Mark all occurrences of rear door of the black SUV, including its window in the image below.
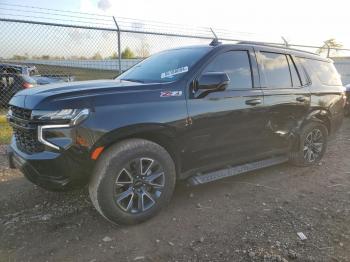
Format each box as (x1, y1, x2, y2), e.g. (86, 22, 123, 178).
(257, 49, 311, 153)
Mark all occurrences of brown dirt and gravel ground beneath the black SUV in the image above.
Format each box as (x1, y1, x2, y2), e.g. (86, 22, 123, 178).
(0, 120, 350, 262)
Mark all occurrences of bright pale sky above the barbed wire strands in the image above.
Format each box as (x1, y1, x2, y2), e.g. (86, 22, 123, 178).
(0, 0, 350, 50)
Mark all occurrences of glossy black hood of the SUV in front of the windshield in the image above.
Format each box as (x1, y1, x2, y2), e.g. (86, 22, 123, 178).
(9, 80, 162, 110)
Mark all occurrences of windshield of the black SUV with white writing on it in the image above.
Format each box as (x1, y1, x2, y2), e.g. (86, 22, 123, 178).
(116, 47, 209, 83)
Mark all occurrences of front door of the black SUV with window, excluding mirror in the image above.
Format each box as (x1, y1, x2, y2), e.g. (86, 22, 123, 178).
(183, 47, 264, 172)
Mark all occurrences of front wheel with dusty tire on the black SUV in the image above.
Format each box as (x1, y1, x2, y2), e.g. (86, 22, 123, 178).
(89, 139, 176, 224)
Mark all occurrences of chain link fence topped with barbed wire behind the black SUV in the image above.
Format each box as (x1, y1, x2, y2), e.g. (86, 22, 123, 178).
(0, 5, 350, 108)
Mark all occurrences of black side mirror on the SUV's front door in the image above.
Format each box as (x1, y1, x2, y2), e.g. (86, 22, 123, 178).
(196, 72, 230, 91)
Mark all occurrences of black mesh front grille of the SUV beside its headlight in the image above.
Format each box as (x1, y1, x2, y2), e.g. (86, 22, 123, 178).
(9, 106, 44, 154)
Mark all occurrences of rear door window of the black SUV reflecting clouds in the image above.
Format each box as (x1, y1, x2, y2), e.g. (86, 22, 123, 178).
(260, 52, 292, 88)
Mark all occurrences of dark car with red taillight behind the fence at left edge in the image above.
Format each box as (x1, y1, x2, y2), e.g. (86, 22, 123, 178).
(0, 73, 37, 108)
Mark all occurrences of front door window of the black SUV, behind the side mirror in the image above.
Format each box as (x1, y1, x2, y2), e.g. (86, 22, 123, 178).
(203, 51, 253, 90)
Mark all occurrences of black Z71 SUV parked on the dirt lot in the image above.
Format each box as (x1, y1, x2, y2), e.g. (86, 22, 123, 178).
(8, 42, 345, 224)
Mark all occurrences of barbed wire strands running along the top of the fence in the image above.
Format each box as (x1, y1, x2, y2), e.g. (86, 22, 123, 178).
(0, 3, 350, 51)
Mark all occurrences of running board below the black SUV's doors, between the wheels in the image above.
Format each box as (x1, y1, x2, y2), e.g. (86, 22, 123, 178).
(188, 156, 288, 186)
